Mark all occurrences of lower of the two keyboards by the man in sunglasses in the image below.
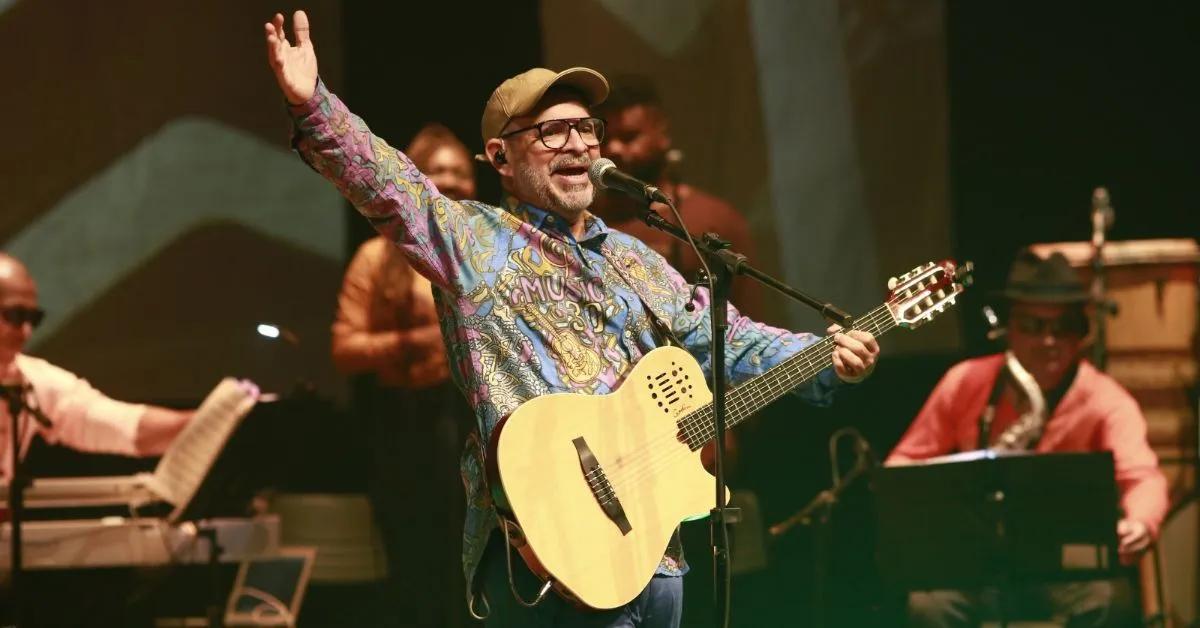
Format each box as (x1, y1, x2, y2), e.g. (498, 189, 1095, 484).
(0, 515, 280, 570)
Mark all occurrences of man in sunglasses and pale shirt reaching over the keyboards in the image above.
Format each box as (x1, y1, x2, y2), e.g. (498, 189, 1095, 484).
(0, 253, 193, 478)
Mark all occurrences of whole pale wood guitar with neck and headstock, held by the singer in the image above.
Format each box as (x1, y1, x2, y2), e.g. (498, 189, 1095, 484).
(487, 261, 971, 609)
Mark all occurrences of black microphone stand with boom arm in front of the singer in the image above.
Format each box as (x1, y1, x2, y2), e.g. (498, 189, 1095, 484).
(642, 207, 853, 627)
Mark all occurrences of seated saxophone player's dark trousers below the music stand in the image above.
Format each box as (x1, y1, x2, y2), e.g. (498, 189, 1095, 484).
(908, 580, 1138, 628)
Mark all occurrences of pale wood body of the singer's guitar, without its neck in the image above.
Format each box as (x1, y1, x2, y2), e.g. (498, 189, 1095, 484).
(492, 347, 728, 609)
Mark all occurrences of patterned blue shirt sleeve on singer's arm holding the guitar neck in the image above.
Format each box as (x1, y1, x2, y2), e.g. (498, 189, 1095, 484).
(662, 241, 852, 406)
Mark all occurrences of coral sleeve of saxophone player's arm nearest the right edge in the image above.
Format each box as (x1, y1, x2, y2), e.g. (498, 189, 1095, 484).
(1100, 396, 1169, 537)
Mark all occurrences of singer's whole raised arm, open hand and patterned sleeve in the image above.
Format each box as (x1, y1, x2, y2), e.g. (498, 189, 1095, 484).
(265, 11, 482, 292)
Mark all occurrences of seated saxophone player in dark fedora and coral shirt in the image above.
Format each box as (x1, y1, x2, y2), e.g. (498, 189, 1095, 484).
(884, 250, 1168, 627)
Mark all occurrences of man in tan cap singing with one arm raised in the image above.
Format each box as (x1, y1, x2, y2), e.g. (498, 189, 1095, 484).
(265, 11, 878, 628)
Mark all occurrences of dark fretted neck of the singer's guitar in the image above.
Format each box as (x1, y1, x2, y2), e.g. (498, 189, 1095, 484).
(680, 304, 896, 449)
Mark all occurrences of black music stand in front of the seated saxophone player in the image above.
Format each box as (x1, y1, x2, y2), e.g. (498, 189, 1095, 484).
(875, 450, 1121, 626)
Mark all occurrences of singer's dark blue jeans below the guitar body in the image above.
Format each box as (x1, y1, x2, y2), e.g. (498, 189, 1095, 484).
(476, 536, 683, 628)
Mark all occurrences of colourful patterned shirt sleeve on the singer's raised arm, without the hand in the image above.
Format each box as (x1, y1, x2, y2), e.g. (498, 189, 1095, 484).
(288, 79, 490, 293)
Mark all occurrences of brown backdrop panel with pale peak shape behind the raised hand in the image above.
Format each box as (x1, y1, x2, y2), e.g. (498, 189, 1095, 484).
(0, 0, 344, 399)
